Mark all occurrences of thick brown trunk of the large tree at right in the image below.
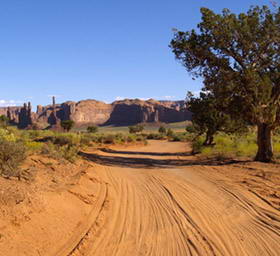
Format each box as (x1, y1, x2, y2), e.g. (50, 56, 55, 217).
(255, 123, 273, 163)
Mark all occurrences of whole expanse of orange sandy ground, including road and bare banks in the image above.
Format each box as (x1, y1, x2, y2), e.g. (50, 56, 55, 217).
(0, 141, 280, 256)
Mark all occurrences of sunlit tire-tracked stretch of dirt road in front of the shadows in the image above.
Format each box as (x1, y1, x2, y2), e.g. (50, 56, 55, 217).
(63, 141, 280, 256)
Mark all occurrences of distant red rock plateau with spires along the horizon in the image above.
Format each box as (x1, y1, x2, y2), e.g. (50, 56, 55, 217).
(0, 98, 191, 129)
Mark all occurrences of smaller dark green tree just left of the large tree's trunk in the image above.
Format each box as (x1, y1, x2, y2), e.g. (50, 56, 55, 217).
(186, 92, 246, 146)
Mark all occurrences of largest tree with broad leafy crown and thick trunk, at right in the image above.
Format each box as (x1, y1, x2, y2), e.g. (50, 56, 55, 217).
(170, 6, 280, 162)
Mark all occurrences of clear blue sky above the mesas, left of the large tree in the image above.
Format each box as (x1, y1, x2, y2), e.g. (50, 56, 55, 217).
(0, 0, 269, 106)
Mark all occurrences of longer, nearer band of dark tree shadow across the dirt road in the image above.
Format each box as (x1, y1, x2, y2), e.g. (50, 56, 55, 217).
(79, 152, 245, 169)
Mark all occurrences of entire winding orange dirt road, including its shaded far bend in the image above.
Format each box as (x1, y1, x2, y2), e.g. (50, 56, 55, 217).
(62, 141, 280, 256)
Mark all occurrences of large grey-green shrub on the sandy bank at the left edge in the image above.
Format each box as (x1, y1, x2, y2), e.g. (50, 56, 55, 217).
(0, 139, 26, 179)
